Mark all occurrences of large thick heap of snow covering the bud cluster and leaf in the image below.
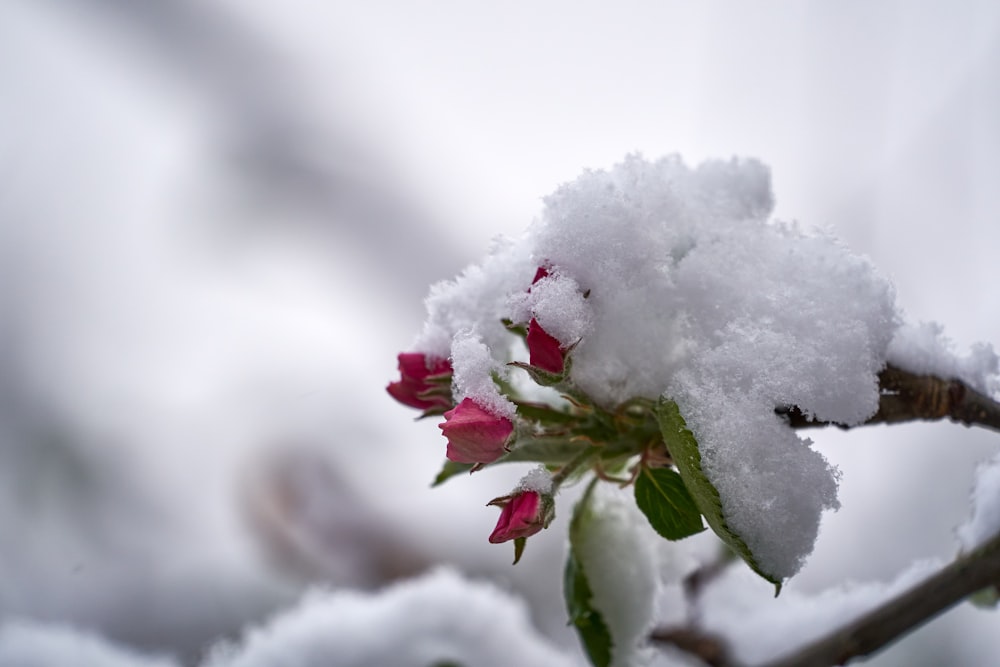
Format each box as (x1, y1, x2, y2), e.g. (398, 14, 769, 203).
(415, 156, 898, 579)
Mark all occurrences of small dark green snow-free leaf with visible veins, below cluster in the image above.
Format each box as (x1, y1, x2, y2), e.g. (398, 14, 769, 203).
(635, 467, 705, 540)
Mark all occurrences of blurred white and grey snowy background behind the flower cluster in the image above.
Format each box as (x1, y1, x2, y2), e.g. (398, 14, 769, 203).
(0, 0, 1000, 665)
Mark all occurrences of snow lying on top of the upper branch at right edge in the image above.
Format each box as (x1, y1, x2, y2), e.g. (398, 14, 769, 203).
(886, 322, 1000, 395)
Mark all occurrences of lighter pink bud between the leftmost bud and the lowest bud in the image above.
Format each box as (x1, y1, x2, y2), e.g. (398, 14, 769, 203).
(439, 398, 514, 463)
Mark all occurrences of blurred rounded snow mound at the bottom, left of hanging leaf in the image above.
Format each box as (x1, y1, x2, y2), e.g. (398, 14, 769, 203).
(203, 570, 574, 667)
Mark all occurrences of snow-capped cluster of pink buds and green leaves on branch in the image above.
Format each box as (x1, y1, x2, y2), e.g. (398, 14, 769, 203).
(389, 156, 916, 664)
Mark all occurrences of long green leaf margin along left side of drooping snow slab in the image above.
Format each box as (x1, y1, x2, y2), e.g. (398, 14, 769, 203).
(656, 398, 781, 596)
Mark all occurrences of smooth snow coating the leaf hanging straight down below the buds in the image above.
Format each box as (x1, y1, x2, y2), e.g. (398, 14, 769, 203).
(576, 484, 661, 667)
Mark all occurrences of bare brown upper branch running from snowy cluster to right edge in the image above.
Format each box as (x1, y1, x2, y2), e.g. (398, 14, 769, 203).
(776, 366, 1000, 431)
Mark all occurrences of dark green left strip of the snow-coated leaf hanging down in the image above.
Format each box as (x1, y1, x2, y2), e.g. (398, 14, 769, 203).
(563, 480, 614, 667)
